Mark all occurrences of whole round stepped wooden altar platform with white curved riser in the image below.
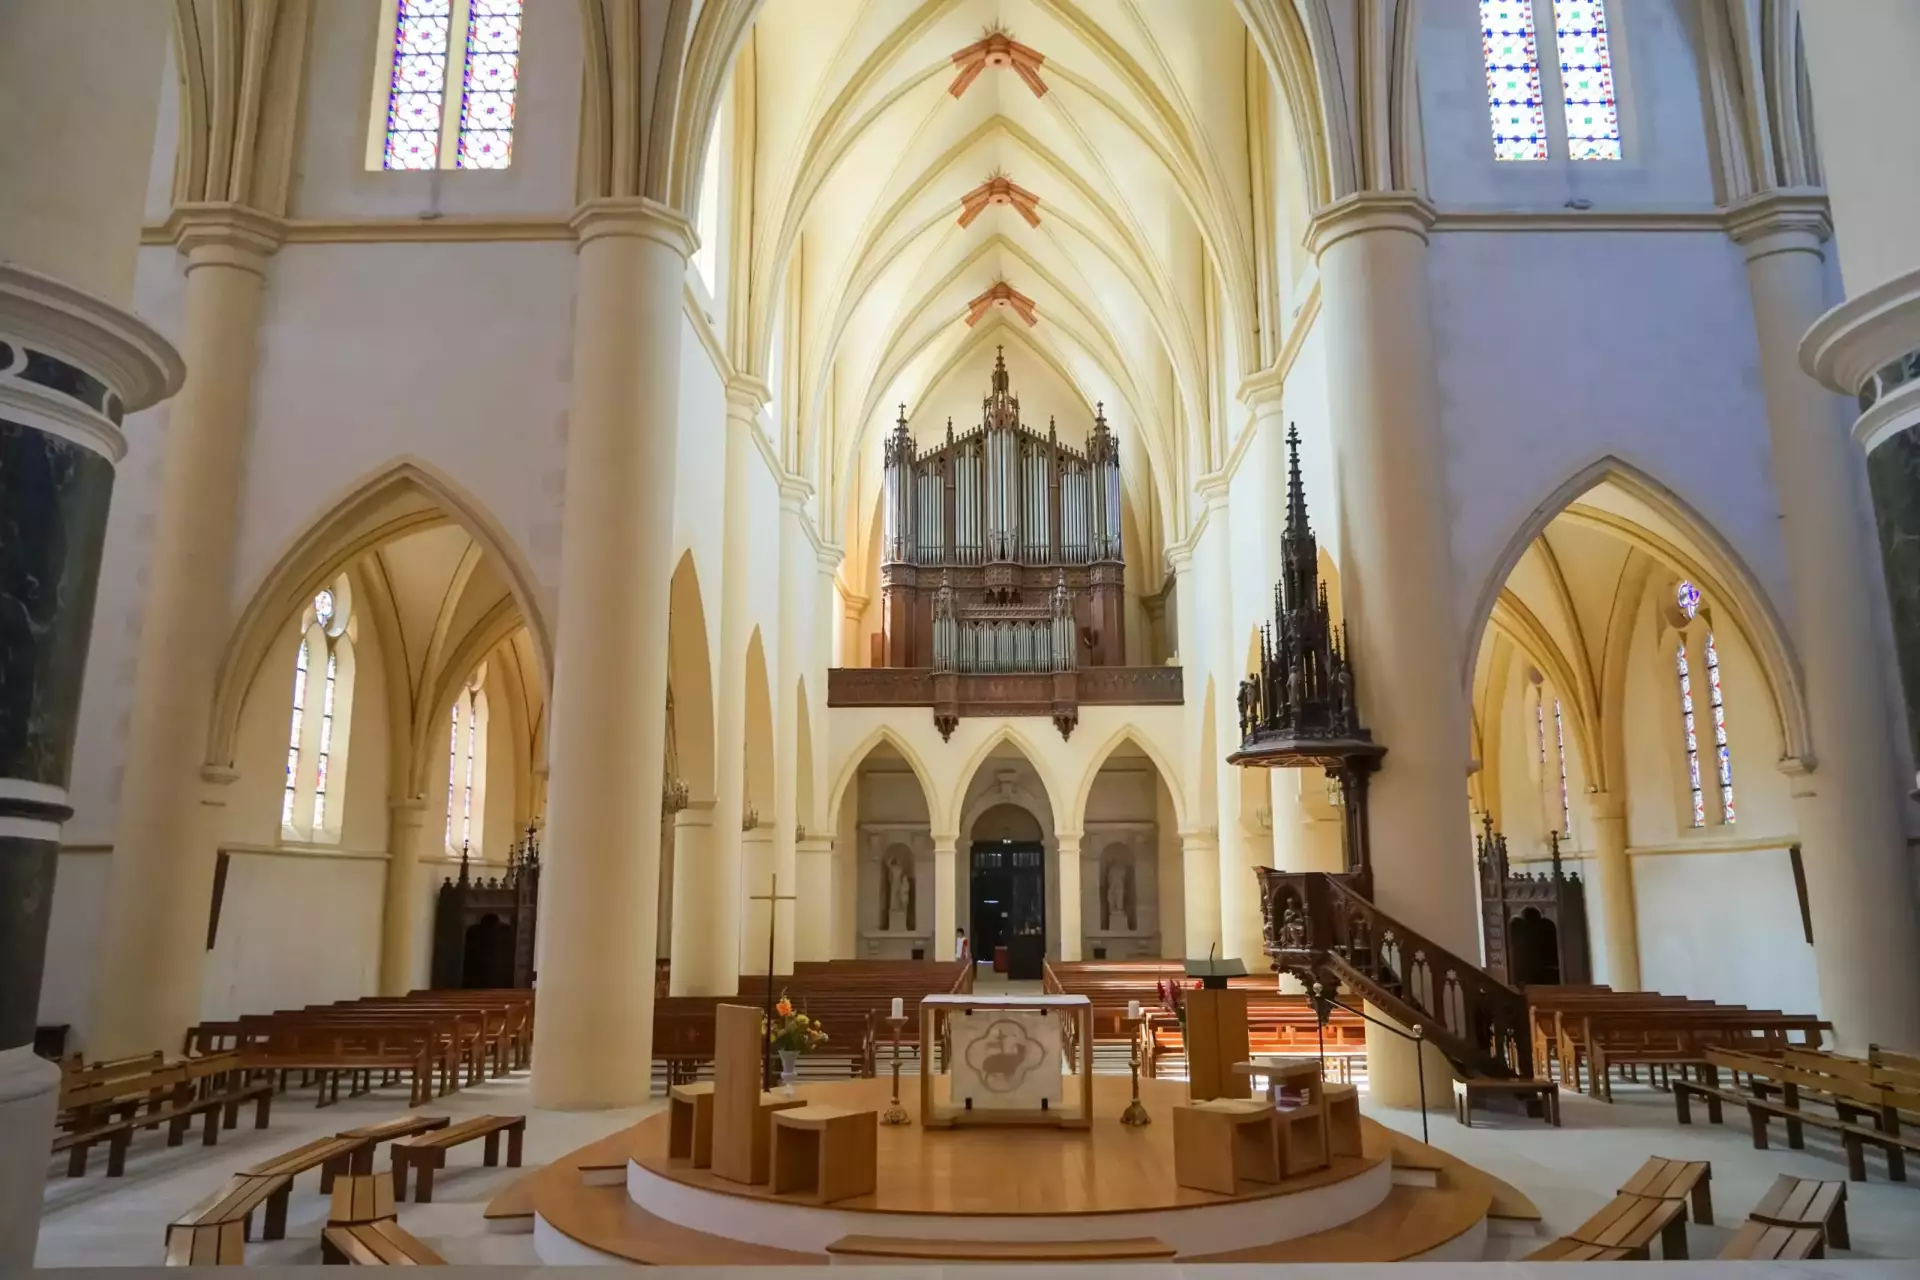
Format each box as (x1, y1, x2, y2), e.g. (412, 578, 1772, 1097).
(516, 1077, 1492, 1265)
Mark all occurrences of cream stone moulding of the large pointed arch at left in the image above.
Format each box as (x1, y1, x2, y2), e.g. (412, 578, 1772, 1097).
(205, 455, 553, 768)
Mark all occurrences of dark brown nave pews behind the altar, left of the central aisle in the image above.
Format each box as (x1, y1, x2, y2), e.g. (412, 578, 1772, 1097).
(653, 960, 973, 1084)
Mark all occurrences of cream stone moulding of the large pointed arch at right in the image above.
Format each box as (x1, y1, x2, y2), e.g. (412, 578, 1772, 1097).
(1461, 453, 1814, 771)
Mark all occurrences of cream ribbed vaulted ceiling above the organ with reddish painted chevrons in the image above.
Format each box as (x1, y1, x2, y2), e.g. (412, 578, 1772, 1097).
(732, 0, 1271, 571)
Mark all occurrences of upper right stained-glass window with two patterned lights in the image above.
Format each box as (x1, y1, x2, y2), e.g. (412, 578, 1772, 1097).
(1480, 0, 1620, 159)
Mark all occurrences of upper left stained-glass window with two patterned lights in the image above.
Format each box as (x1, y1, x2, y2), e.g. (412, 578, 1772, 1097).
(367, 0, 524, 169)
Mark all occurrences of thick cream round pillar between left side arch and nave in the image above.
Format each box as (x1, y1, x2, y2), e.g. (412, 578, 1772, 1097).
(534, 198, 693, 1109)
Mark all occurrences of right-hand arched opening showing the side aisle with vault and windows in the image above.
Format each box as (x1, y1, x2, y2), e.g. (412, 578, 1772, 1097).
(1469, 464, 1818, 1009)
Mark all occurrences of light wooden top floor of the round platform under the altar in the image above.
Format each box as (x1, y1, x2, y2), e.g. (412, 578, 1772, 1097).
(632, 1075, 1388, 1217)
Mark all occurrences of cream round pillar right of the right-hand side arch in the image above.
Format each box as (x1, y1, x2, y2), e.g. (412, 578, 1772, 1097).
(1732, 192, 1920, 1050)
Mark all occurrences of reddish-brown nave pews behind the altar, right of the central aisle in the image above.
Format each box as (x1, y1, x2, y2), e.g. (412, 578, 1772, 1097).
(1046, 960, 1367, 1079)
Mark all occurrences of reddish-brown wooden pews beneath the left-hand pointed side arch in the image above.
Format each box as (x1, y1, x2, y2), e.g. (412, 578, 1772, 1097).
(184, 988, 534, 1107)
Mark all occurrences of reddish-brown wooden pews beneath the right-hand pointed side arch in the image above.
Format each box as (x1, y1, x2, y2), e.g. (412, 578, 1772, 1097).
(1526, 986, 1834, 1102)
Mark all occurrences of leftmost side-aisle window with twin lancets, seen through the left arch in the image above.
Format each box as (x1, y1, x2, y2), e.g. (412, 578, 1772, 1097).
(280, 578, 353, 842)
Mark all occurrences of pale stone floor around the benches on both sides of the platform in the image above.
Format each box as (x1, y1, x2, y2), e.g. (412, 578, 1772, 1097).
(36, 1075, 1920, 1274)
